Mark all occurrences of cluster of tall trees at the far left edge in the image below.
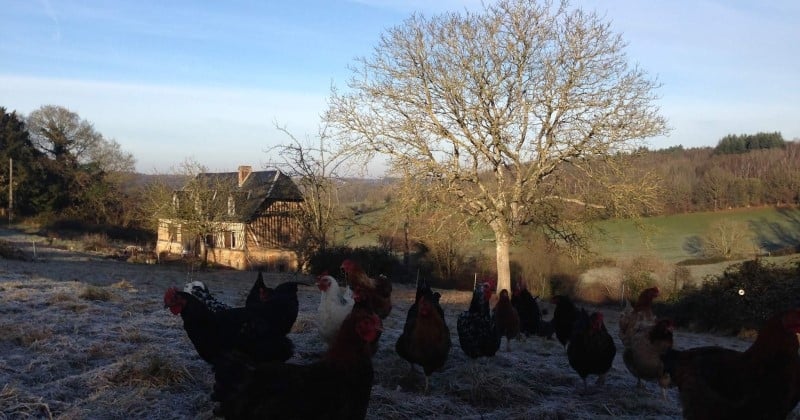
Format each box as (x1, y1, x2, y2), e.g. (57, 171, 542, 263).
(0, 105, 137, 227)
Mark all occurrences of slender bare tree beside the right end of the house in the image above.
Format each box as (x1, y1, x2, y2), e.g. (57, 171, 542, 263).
(267, 125, 344, 266)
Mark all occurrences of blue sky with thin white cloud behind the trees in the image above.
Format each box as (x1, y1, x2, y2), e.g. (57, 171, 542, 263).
(0, 0, 800, 175)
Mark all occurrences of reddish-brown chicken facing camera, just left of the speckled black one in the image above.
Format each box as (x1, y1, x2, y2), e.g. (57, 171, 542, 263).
(395, 281, 451, 392)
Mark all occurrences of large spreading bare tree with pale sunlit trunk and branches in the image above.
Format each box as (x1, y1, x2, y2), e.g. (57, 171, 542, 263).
(325, 0, 666, 294)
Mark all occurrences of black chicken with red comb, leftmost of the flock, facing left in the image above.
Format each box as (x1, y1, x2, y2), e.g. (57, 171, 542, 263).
(164, 287, 294, 366)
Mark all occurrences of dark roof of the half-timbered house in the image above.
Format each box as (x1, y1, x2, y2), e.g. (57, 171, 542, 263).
(192, 170, 303, 220)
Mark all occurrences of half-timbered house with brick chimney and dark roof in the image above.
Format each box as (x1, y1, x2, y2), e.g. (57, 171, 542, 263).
(156, 166, 303, 271)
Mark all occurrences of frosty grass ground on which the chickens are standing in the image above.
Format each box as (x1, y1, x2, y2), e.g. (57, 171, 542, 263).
(0, 230, 800, 419)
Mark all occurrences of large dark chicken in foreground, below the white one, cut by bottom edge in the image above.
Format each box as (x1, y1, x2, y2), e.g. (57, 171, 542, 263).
(211, 304, 382, 420)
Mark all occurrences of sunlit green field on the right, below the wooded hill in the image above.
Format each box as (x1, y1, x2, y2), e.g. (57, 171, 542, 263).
(593, 208, 800, 263)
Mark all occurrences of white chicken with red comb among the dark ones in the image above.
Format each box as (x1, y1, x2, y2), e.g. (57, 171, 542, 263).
(317, 274, 355, 344)
